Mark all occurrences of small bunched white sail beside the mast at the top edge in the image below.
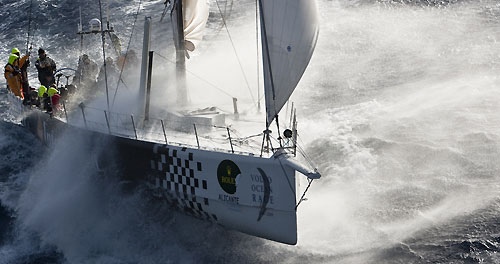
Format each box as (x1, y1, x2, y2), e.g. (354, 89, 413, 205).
(182, 0, 209, 51)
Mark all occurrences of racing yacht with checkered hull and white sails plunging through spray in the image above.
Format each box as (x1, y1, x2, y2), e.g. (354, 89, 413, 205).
(18, 0, 320, 245)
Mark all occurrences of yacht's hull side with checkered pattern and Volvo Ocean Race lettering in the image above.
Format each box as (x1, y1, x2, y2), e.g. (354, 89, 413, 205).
(23, 105, 308, 245)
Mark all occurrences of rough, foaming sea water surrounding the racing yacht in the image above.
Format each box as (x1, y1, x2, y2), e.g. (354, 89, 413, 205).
(0, 0, 500, 263)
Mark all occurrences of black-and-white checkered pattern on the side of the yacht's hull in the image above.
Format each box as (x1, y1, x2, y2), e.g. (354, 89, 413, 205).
(151, 145, 217, 221)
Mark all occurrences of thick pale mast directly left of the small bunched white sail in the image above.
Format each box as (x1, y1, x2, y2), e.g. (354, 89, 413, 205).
(175, 0, 187, 106)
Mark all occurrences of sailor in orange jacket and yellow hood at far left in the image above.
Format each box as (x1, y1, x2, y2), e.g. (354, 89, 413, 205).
(4, 49, 29, 99)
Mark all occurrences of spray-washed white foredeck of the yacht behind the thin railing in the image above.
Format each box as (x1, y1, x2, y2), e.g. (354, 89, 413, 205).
(59, 101, 278, 156)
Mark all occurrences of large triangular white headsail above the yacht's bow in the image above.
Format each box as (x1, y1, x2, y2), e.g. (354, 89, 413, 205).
(260, 0, 319, 125)
